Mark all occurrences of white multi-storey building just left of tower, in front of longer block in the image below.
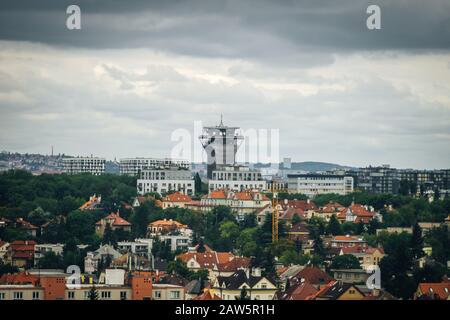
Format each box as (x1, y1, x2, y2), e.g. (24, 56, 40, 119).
(137, 167, 195, 195)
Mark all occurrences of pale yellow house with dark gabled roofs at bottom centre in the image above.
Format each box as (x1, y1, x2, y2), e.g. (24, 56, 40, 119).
(211, 269, 277, 301)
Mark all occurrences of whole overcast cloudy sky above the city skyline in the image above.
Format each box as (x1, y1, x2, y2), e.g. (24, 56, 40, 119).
(0, 0, 450, 168)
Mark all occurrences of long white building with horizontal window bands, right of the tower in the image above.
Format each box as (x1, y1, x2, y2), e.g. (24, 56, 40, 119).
(288, 174, 353, 197)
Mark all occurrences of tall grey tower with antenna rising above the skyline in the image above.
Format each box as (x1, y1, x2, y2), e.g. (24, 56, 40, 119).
(199, 115, 244, 179)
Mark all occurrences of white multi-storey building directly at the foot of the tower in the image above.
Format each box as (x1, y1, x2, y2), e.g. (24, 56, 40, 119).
(208, 166, 267, 192)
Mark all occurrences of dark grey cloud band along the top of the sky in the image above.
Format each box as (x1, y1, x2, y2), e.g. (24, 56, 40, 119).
(0, 0, 450, 63)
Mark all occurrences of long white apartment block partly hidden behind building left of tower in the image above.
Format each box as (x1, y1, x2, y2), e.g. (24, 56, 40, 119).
(119, 158, 190, 176)
